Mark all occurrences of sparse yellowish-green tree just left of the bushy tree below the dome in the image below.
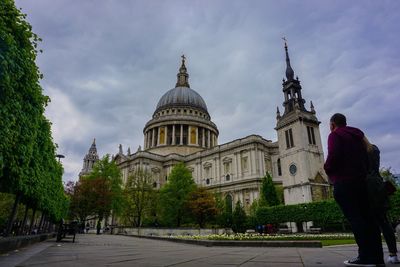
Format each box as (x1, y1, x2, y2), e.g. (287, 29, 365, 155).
(124, 169, 155, 227)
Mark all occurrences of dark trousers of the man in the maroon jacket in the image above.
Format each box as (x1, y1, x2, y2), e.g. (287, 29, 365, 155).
(333, 180, 383, 263)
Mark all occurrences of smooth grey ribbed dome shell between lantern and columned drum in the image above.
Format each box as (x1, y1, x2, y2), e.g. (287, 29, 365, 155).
(155, 86, 208, 113)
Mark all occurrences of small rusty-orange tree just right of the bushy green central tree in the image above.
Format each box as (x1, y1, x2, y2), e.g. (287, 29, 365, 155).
(188, 187, 218, 228)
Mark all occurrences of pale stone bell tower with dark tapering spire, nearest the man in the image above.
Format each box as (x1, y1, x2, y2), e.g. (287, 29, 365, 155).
(275, 39, 329, 204)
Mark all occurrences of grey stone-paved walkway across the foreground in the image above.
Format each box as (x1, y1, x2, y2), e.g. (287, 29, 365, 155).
(0, 234, 398, 267)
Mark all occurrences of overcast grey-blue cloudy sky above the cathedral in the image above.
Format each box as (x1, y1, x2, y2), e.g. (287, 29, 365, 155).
(16, 0, 400, 181)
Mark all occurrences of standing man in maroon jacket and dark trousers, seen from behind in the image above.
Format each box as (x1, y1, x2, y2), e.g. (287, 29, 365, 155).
(324, 113, 384, 266)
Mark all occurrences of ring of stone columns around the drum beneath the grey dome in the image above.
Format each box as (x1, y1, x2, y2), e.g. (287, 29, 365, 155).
(144, 124, 217, 149)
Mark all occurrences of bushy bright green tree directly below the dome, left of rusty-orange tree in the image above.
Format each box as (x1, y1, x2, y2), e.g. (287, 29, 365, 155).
(159, 163, 196, 227)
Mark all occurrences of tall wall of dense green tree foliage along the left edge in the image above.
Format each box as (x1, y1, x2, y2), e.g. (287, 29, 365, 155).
(0, 0, 68, 235)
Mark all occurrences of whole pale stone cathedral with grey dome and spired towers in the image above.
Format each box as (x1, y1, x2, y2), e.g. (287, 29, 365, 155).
(80, 43, 329, 209)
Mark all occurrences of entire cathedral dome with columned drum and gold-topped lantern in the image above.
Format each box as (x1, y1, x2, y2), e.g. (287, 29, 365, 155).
(143, 56, 219, 156)
